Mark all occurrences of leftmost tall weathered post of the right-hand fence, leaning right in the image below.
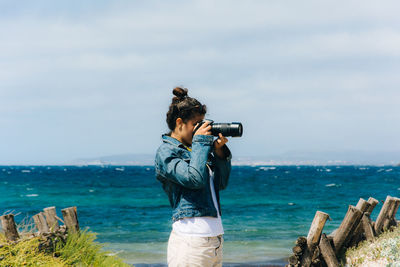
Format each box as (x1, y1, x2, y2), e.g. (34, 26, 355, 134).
(300, 211, 329, 267)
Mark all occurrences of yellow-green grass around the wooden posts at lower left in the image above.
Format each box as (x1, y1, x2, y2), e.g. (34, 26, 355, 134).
(0, 230, 129, 267)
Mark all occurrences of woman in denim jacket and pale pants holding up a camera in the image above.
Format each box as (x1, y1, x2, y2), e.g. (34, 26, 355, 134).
(155, 87, 231, 267)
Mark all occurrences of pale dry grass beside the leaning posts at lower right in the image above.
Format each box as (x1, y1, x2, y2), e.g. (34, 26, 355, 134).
(346, 227, 400, 267)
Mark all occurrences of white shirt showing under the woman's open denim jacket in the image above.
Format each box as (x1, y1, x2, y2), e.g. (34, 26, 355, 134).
(172, 166, 224, 237)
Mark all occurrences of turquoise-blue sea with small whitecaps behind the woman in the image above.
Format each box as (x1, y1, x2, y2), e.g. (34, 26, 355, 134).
(0, 165, 400, 267)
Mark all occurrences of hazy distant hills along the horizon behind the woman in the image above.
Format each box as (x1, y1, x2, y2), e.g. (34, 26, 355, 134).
(72, 151, 400, 165)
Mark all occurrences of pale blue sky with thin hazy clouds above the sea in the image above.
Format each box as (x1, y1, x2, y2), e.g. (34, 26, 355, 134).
(0, 0, 400, 165)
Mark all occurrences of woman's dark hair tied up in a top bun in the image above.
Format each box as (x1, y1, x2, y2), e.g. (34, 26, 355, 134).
(167, 87, 207, 131)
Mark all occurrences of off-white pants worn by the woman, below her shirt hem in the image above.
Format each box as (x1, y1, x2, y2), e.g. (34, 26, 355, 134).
(168, 231, 224, 267)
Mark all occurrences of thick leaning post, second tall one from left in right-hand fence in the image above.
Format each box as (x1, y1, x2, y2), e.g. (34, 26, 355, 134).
(333, 205, 362, 253)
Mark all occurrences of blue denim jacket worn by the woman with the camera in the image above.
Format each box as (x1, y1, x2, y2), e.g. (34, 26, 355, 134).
(155, 135, 232, 221)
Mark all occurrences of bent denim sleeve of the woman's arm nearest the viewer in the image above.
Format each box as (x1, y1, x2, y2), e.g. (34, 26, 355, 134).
(156, 135, 213, 189)
